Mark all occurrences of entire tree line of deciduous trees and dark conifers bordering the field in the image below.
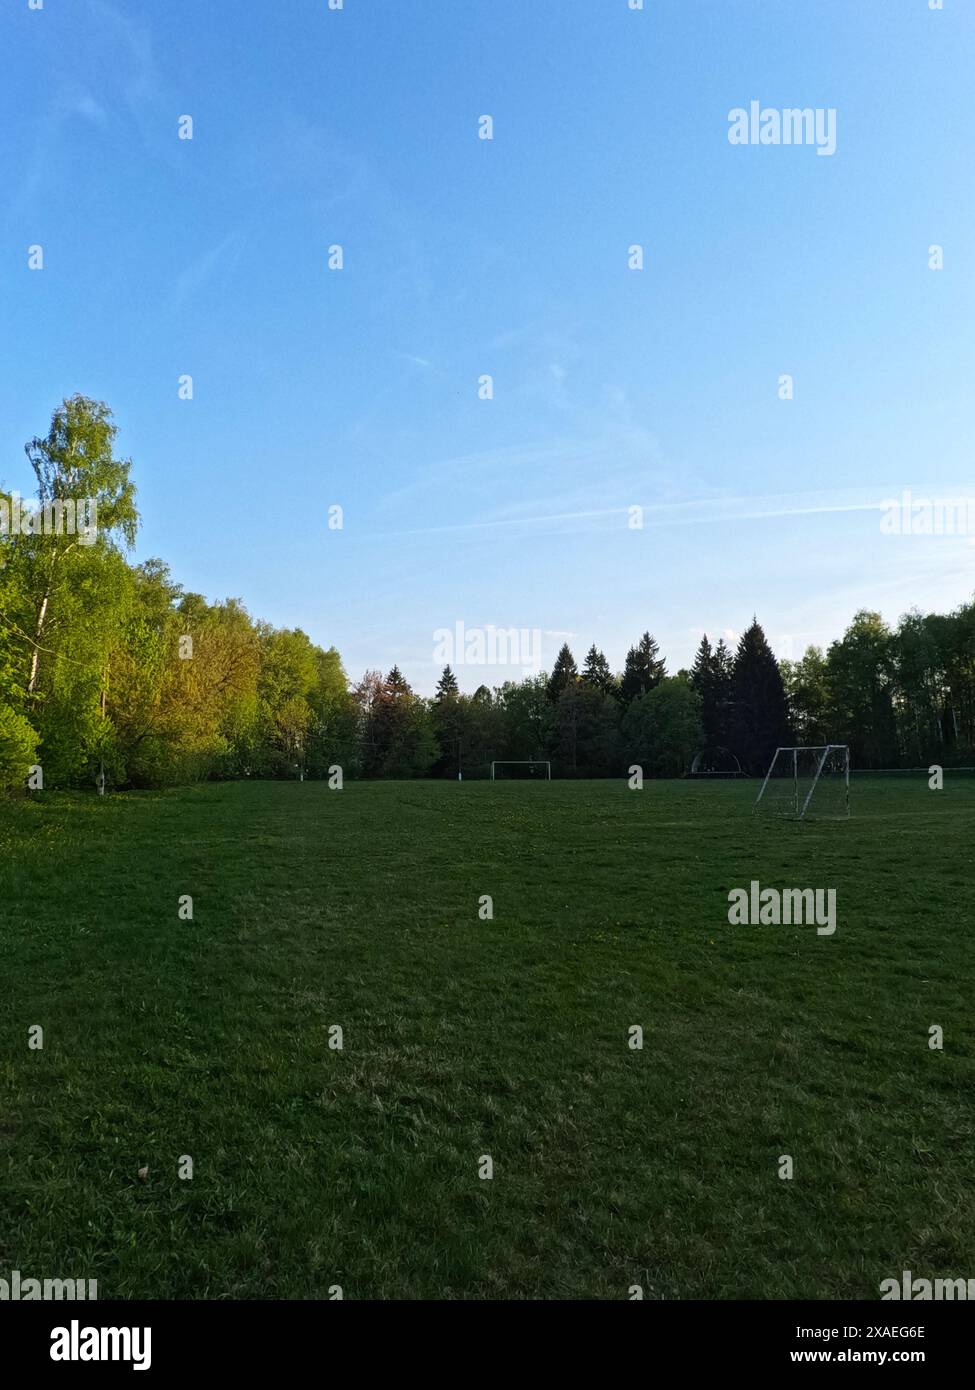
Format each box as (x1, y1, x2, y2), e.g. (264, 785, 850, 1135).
(0, 396, 975, 787)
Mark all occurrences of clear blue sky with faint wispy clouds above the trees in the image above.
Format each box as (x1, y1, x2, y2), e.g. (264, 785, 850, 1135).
(0, 0, 975, 694)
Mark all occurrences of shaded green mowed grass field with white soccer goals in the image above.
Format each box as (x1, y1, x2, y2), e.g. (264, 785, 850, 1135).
(0, 777, 975, 1298)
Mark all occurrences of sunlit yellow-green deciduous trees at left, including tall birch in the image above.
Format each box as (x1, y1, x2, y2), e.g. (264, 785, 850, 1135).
(0, 396, 359, 787)
